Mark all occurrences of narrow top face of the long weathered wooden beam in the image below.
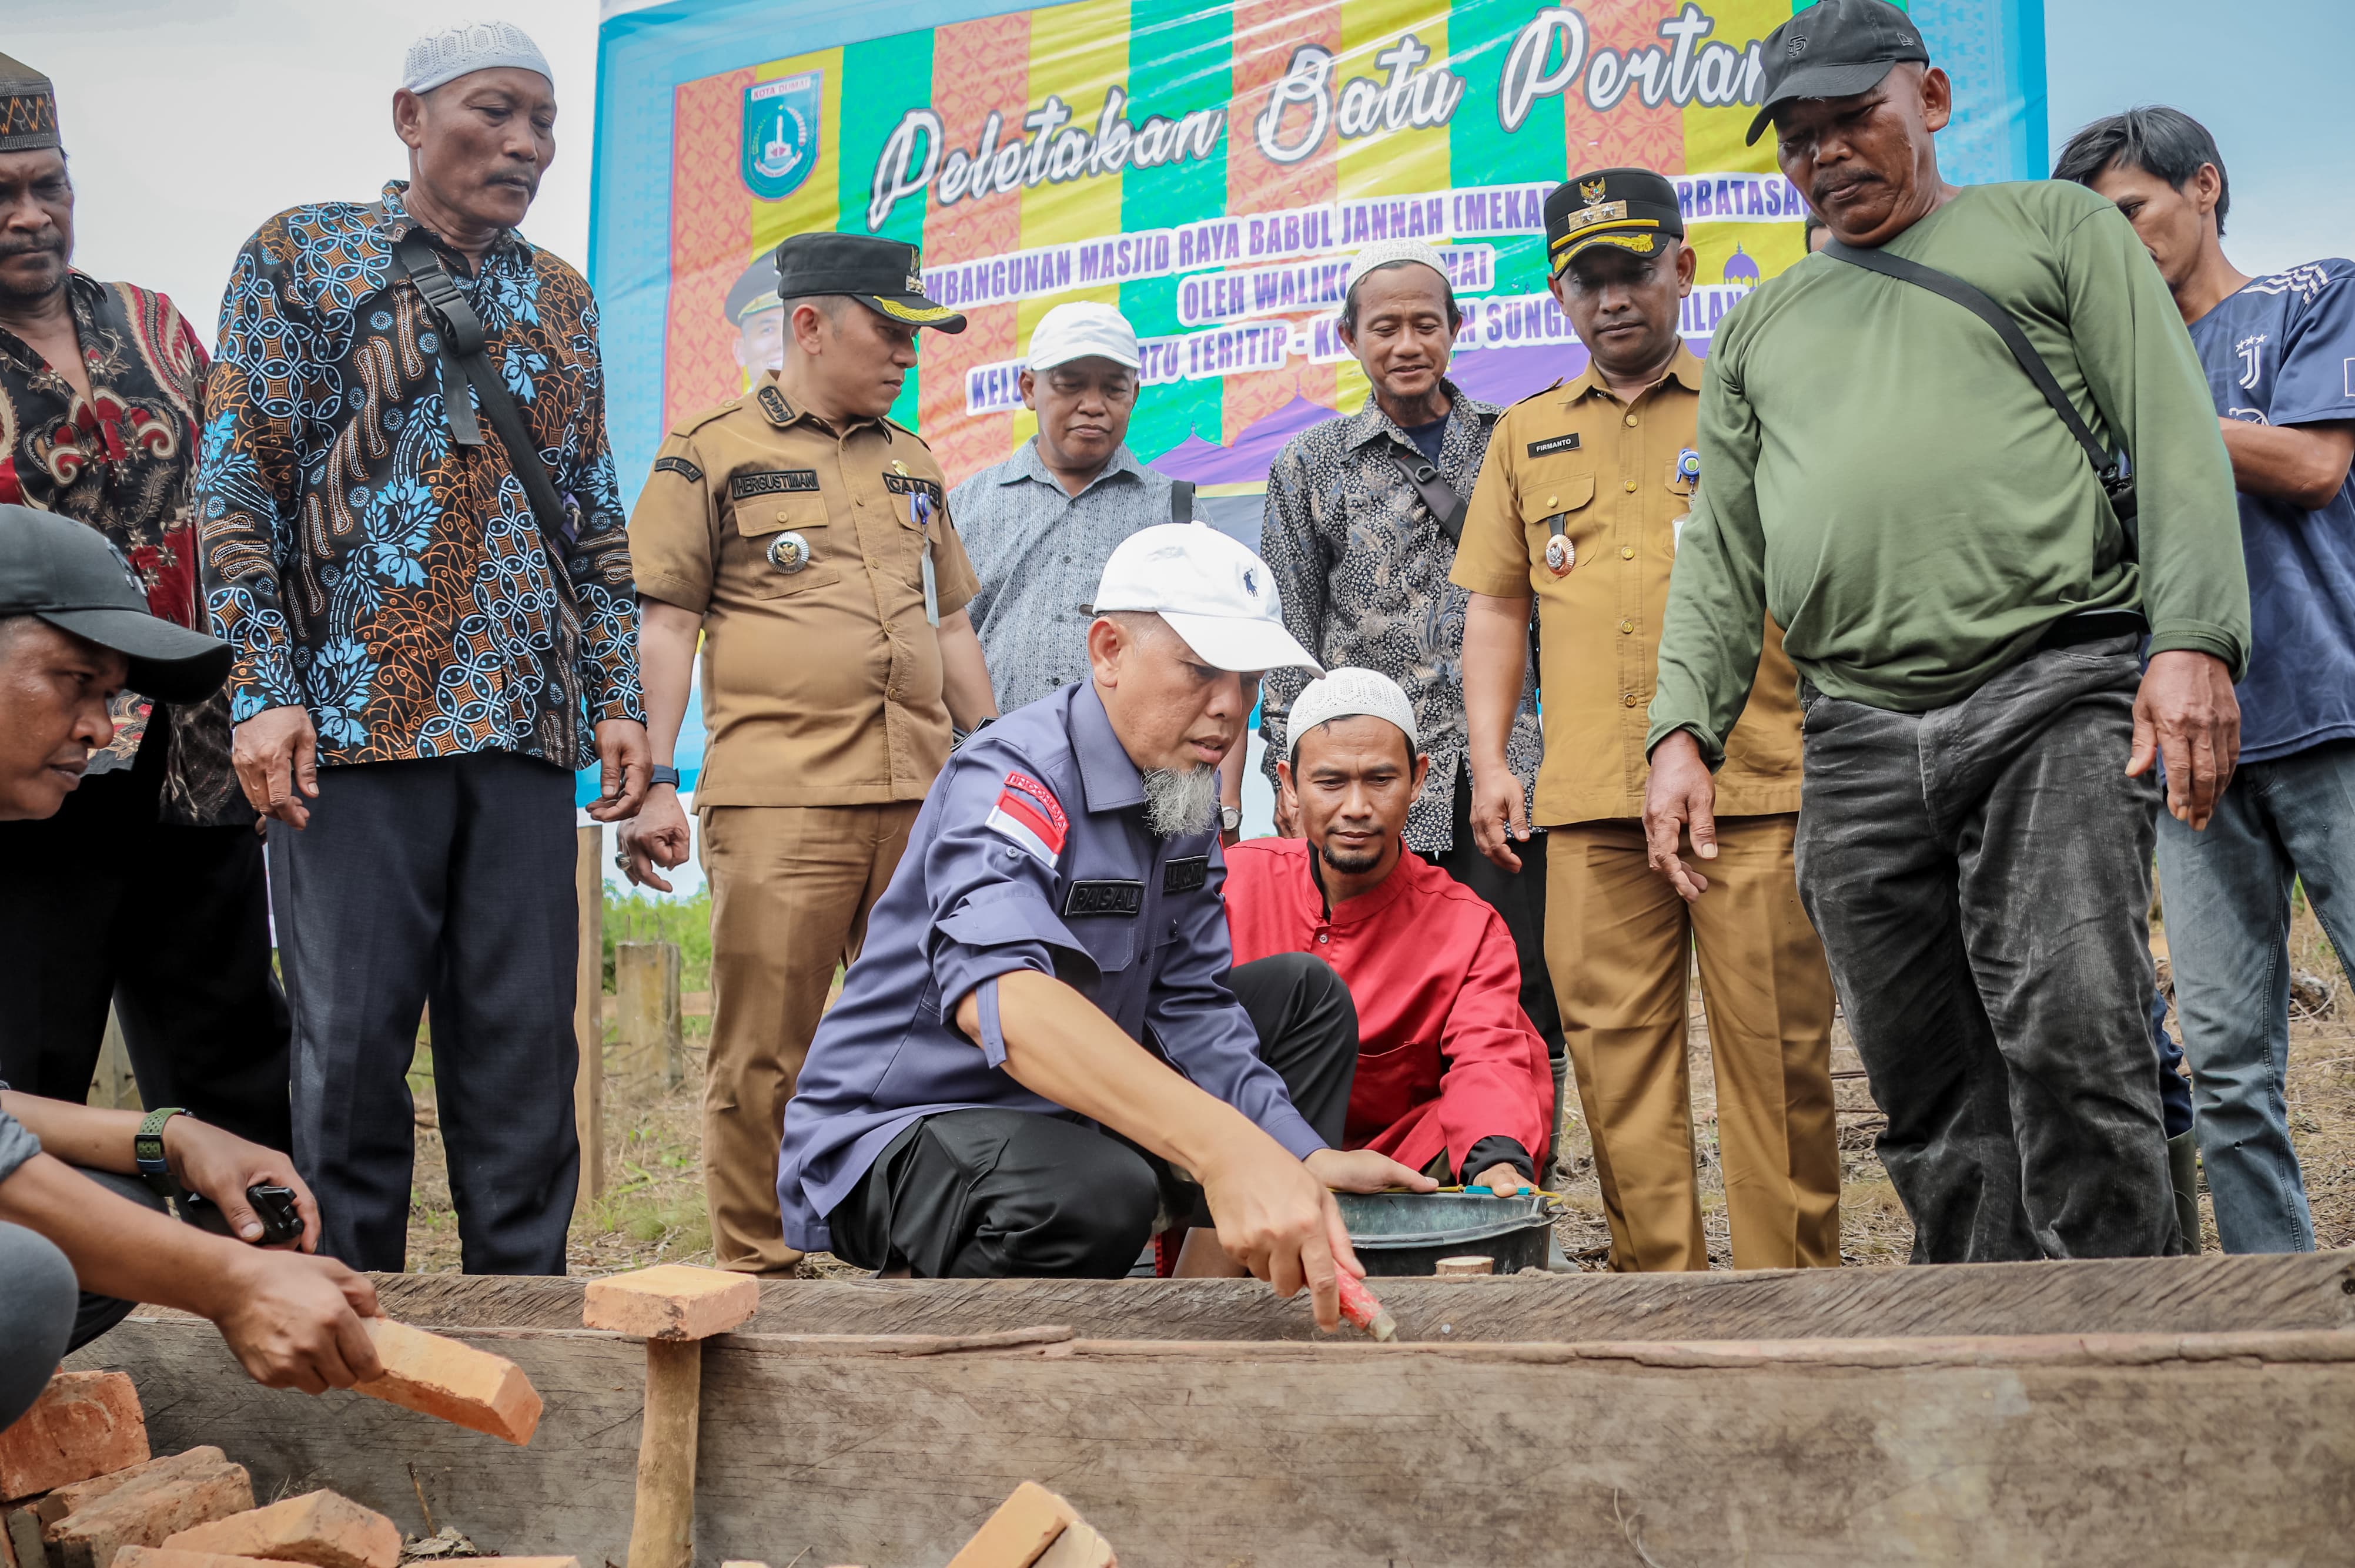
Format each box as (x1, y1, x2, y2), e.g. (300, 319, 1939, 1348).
(357, 1252, 2355, 1342)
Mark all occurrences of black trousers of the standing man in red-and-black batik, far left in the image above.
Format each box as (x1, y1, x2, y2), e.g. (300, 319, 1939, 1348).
(0, 734, 290, 1149)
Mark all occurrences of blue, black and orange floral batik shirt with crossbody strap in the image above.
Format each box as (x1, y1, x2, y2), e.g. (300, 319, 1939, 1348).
(198, 181, 643, 768)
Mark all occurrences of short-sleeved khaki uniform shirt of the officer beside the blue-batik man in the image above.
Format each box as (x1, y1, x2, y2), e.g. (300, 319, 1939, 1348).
(629, 372, 975, 810)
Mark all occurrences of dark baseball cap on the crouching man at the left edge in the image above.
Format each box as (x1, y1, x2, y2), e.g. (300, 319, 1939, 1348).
(0, 506, 229, 704)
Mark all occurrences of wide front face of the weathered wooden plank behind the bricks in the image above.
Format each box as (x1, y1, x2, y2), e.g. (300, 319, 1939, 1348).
(68, 1318, 2355, 1568)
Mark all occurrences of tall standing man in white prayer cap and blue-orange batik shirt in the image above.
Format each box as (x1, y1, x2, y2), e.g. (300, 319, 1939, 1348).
(195, 21, 650, 1274)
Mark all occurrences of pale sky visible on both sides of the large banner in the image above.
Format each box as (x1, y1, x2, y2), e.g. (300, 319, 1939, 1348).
(23, 0, 2355, 341)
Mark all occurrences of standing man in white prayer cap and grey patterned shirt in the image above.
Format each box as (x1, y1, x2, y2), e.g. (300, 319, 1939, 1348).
(1260, 240, 1561, 1130)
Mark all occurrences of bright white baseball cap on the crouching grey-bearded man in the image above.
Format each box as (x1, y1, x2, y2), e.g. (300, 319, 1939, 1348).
(1095, 522, 1323, 676)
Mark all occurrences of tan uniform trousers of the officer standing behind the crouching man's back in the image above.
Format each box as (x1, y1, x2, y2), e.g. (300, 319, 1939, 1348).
(702, 800, 923, 1274)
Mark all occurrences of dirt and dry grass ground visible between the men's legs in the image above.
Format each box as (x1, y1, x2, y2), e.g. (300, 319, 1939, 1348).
(410, 904, 2355, 1274)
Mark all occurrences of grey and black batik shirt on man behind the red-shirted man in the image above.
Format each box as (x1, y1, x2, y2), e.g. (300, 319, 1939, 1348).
(1260, 381, 1543, 855)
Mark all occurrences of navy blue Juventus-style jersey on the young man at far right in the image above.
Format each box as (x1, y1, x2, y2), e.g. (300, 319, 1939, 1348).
(2193, 259, 2355, 763)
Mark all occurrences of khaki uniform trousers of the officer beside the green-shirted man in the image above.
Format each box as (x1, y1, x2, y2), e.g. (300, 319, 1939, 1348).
(1545, 815, 1839, 1271)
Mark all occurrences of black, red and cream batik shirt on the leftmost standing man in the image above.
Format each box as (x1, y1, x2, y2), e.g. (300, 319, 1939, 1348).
(0, 271, 240, 824)
